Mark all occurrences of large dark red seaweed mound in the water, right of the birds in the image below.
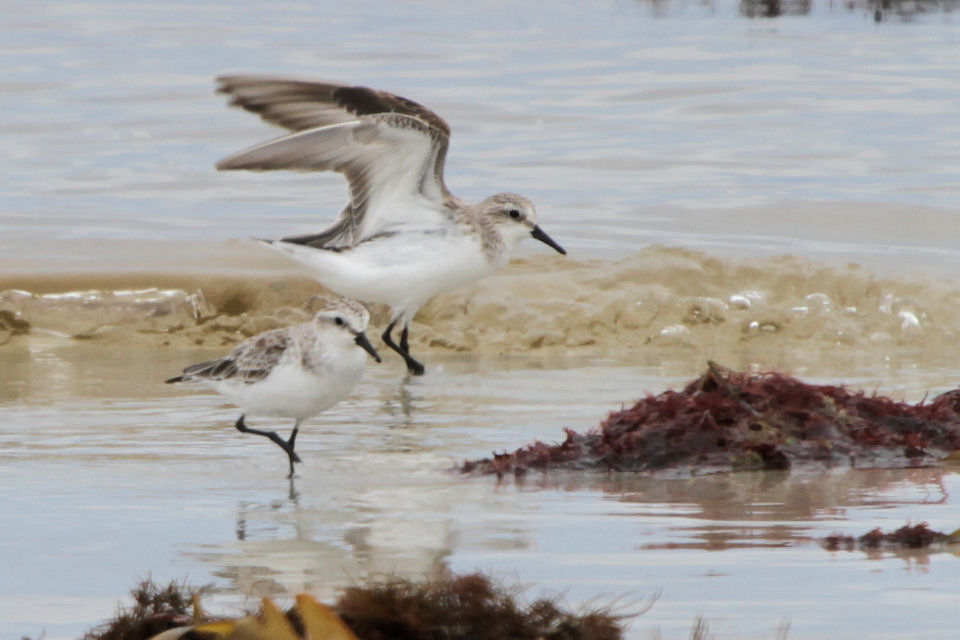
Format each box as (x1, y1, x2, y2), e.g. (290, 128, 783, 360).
(459, 363, 960, 477)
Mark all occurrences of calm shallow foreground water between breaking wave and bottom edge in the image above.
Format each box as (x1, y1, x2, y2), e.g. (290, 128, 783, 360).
(0, 340, 960, 638)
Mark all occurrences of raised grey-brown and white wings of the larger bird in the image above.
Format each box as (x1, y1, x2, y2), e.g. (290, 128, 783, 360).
(217, 75, 455, 248)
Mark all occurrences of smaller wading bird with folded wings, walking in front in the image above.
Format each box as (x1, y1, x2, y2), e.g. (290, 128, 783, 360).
(167, 299, 380, 477)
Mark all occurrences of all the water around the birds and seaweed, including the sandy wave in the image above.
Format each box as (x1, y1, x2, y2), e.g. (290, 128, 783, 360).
(0, 0, 960, 639)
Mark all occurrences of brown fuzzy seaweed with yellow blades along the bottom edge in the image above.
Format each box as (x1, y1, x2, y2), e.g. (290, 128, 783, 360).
(83, 572, 624, 640)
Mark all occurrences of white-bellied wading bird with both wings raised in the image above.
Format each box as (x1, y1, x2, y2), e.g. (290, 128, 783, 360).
(217, 75, 566, 375)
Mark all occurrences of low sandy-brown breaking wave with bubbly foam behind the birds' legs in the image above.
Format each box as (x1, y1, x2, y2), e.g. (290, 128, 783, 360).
(0, 246, 960, 372)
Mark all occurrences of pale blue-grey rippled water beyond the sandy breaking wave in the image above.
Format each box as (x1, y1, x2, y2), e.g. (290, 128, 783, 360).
(0, 1, 960, 269)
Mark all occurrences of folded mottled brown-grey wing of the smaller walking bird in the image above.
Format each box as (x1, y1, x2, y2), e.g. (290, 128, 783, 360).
(167, 329, 291, 384)
